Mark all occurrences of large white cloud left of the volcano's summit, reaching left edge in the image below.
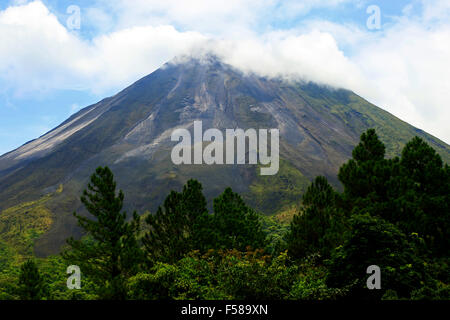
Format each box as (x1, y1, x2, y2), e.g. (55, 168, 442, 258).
(0, 1, 205, 94)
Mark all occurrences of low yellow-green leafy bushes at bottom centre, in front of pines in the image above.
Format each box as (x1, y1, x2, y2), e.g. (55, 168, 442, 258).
(129, 249, 298, 300)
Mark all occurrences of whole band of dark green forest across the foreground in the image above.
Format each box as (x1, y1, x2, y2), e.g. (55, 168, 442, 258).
(0, 129, 450, 300)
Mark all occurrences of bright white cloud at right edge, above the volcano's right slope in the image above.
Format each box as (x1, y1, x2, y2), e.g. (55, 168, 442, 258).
(353, 24, 450, 142)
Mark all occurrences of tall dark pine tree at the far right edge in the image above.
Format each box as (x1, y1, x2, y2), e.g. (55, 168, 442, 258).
(391, 137, 450, 255)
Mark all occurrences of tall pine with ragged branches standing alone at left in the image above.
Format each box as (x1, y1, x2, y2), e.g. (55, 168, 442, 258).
(63, 167, 142, 299)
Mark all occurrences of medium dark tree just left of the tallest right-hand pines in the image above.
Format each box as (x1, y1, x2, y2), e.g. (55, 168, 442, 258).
(286, 177, 344, 259)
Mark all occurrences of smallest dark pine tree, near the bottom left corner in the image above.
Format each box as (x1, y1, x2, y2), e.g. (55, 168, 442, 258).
(17, 260, 49, 300)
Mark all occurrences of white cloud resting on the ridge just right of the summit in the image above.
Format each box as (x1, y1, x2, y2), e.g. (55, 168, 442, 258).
(204, 31, 364, 88)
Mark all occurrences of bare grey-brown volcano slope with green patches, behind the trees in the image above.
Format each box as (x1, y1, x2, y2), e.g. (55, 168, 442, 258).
(0, 54, 450, 255)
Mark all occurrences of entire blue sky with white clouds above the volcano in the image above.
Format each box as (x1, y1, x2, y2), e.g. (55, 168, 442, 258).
(0, 0, 450, 154)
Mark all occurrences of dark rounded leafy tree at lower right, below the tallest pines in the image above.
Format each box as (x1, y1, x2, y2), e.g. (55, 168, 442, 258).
(327, 214, 426, 300)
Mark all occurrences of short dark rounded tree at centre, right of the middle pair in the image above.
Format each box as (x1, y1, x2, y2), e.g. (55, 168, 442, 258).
(212, 188, 266, 251)
